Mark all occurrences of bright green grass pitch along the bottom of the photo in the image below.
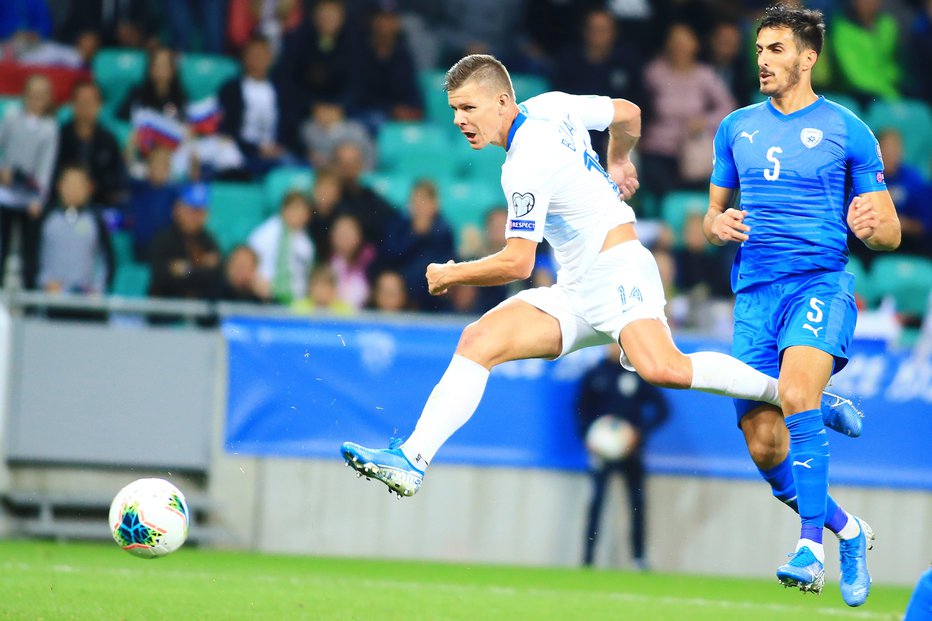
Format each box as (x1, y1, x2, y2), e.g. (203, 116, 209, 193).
(0, 541, 909, 621)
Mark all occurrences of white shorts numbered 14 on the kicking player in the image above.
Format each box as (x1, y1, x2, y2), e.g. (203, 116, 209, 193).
(513, 240, 670, 371)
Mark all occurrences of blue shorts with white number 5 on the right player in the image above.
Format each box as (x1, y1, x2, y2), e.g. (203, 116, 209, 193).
(732, 271, 858, 426)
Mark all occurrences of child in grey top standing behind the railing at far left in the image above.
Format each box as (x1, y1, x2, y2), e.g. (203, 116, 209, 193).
(39, 165, 114, 294)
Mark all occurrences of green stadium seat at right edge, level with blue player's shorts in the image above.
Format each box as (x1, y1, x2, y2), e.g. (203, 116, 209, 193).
(870, 254, 932, 316)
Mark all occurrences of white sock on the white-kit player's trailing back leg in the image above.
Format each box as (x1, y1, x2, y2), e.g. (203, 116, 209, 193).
(687, 351, 780, 407)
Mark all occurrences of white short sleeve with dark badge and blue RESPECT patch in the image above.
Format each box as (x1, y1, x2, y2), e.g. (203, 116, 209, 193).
(502, 139, 555, 242)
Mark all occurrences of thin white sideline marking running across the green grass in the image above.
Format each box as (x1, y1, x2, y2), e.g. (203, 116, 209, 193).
(7, 562, 898, 621)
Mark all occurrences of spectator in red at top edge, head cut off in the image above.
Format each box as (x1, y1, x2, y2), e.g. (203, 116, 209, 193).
(227, 0, 303, 58)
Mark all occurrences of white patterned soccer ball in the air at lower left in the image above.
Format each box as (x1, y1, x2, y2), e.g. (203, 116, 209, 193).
(110, 479, 190, 558)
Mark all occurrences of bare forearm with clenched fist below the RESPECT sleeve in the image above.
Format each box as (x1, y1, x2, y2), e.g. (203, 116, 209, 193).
(427, 237, 537, 295)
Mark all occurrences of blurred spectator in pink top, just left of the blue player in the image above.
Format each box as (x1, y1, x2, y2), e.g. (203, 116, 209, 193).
(639, 24, 735, 195)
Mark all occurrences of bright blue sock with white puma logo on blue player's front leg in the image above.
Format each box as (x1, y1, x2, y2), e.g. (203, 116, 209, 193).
(786, 410, 829, 543)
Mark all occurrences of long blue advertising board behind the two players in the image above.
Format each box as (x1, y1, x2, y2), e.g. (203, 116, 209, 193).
(223, 318, 932, 489)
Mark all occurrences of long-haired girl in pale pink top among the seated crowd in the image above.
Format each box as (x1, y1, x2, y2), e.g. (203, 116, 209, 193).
(330, 214, 375, 309)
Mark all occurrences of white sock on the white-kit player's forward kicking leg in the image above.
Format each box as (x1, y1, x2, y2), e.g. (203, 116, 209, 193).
(401, 355, 489, 470)
